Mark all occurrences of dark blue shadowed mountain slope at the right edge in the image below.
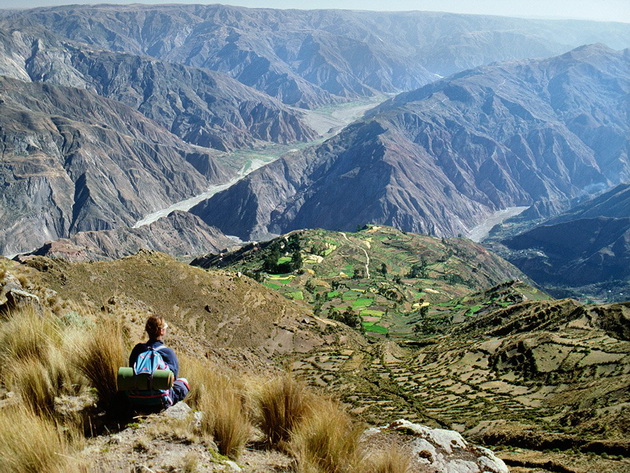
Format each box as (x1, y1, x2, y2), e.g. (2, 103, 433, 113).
(503, 184, 630, 300)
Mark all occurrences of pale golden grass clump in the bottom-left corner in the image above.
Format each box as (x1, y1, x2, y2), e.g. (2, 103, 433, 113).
(0, 407, 82, 473)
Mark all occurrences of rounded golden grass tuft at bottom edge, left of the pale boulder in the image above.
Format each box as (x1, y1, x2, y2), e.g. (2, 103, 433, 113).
(291, 400, 363, 473)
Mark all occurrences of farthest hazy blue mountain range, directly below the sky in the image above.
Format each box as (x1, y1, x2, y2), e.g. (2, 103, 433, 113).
(9, 5, 630, 108)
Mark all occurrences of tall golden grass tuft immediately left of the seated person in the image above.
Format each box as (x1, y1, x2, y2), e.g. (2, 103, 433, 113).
(75, 320, 126, 407)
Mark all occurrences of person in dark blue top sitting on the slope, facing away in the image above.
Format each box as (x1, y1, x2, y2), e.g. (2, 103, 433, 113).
(129, 315, 190, 409)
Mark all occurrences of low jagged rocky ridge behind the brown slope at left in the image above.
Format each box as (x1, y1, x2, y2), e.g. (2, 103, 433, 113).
(17, 211, 235, 262)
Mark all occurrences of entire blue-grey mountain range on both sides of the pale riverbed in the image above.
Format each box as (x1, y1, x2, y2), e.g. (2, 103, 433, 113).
(0, 5, 630, 296)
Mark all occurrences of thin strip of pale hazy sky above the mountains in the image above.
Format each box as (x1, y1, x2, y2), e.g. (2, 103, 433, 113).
(0, 0, 630, 23)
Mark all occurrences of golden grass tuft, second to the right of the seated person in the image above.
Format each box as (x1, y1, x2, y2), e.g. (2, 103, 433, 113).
(256, 374, 315, 450)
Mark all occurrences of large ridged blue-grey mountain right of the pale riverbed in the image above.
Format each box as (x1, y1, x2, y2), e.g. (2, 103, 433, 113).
(193, 45, 630, 239)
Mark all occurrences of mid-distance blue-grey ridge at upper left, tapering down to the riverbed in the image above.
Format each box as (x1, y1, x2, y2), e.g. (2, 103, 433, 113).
(0, 25, 315, 150)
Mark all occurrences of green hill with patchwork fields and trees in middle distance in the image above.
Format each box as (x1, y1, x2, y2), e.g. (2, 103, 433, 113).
(191, 226, 545, 338)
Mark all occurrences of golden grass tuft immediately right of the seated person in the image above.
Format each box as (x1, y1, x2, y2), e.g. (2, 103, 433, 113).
(182, 357, 252, 459)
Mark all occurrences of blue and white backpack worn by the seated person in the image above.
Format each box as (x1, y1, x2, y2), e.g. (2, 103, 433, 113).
(127, 345, 173, 408)
